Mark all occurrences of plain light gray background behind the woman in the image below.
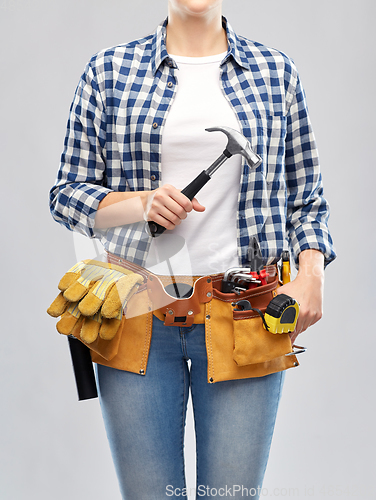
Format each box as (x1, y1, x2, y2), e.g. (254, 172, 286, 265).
(0, 0, 376, 500)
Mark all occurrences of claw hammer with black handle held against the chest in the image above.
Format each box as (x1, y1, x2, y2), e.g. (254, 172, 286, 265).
(148, 127, 262, 238)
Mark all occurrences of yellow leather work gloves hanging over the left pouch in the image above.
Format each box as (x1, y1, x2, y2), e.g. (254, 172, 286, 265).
(47, 260, 143, 344)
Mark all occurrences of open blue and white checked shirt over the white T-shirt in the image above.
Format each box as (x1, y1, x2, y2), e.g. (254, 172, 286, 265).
(50, 18, 335, 272)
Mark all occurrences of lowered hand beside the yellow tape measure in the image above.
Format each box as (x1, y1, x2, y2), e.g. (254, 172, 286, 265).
(277, 249, 324, 343)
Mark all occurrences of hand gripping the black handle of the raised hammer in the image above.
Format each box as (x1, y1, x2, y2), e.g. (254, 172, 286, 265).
(145, 184, 205, 230)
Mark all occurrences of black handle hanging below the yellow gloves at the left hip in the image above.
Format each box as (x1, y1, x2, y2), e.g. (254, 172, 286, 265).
(68, 336, 98, 401)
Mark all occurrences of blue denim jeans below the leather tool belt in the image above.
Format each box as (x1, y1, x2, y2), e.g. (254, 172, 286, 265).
(97, 318, 284, 500)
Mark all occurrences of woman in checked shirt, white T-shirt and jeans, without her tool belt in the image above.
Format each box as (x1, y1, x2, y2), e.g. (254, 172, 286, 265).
(51, 0, 335, 500)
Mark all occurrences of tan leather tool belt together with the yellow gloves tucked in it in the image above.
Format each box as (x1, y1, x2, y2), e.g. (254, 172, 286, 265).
(46, 254, 298, 383)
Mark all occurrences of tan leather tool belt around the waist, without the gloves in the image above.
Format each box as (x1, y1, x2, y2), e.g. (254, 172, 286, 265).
(101, 254, 299, 383)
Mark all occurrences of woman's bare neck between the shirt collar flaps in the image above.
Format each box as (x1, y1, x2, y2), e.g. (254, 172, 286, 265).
(166, 9, 227, 57)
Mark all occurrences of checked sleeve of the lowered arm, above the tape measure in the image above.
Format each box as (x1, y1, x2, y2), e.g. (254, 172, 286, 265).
(285, 73, 336, 266)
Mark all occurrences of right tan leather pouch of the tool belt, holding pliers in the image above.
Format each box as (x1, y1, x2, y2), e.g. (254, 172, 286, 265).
(205, 266, 299, 383)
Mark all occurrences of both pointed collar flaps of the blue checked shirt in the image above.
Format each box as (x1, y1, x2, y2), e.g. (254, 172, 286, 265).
(151, 17, 250, 75)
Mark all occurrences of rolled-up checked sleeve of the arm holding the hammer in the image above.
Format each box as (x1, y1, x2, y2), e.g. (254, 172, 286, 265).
(50, 63, 112, 238)
